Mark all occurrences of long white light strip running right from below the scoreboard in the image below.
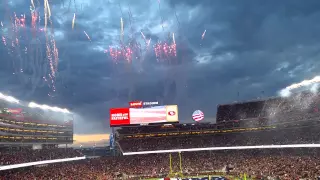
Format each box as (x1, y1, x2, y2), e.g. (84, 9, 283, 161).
(123, 144, 320, 156)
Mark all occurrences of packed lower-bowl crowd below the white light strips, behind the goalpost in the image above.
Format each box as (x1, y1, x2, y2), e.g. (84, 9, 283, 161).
(0, 148, 320, 180)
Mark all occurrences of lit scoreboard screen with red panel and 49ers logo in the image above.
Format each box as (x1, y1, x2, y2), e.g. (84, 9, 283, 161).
(110, 105, 179, 126)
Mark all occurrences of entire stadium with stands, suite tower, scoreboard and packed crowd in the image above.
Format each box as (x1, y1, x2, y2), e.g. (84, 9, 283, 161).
(0, 92, 320, 180)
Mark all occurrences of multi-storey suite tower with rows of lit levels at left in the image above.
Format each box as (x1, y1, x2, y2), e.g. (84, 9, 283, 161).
(0, 104, 73, 144)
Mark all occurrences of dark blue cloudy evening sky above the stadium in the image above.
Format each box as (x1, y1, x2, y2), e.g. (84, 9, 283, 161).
(0, 0, 320, 134)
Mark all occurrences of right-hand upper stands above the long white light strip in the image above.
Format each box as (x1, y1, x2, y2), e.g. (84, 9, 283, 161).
(118, 93, 320, 152)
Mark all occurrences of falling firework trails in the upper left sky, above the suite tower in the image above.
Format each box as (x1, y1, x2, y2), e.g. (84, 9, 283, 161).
(1, 0, 59, 93)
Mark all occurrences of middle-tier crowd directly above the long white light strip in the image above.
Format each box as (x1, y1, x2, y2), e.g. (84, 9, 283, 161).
(119, 124, 320, 152)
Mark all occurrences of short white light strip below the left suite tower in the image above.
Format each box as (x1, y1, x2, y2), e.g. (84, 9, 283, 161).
(0, 156, 86, 171)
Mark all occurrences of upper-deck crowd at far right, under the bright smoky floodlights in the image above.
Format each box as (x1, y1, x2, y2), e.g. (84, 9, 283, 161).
(217, 92, 320, 122)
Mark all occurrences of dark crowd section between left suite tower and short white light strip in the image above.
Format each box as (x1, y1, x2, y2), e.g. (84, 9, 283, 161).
(0, 148, 83, 165)
